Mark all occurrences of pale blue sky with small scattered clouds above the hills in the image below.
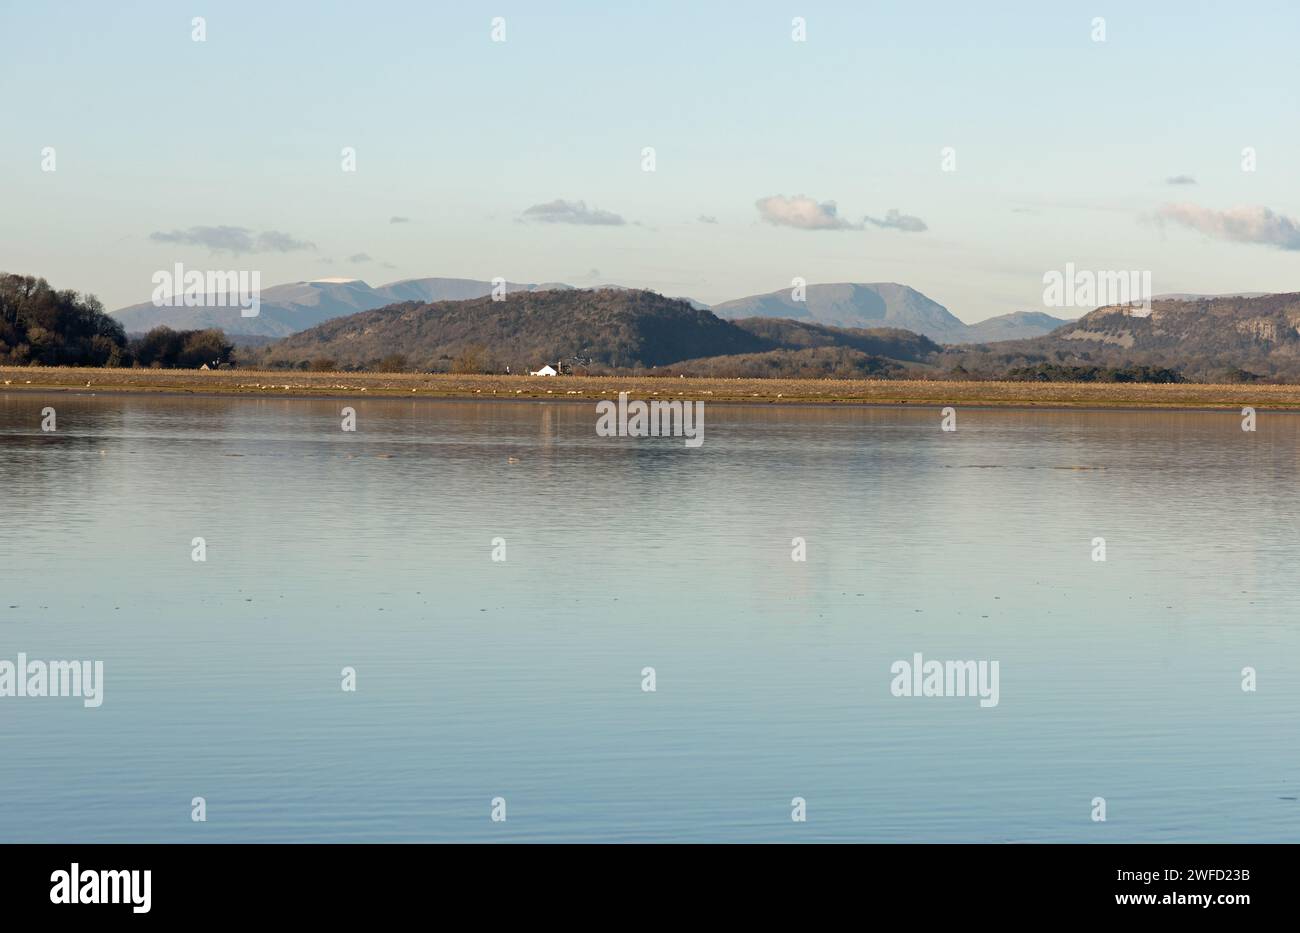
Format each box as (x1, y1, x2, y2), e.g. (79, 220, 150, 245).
(0, 0, 1300, 321)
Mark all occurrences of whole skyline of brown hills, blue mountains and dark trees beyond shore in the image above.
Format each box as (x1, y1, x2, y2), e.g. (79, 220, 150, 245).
(17, 261, 1300, 382)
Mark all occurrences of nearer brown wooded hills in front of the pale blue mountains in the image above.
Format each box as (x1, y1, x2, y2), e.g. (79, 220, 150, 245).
(261, 288, 1300, 382)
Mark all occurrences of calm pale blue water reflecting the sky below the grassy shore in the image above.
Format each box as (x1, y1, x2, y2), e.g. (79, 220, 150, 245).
(0, 394, 1300, 842)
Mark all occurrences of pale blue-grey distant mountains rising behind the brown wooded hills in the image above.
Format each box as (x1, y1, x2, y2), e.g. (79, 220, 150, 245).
(113, 278, 1066, 343)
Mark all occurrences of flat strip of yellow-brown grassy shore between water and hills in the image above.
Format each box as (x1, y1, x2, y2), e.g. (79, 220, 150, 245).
(0, 366, 1300, 411)
